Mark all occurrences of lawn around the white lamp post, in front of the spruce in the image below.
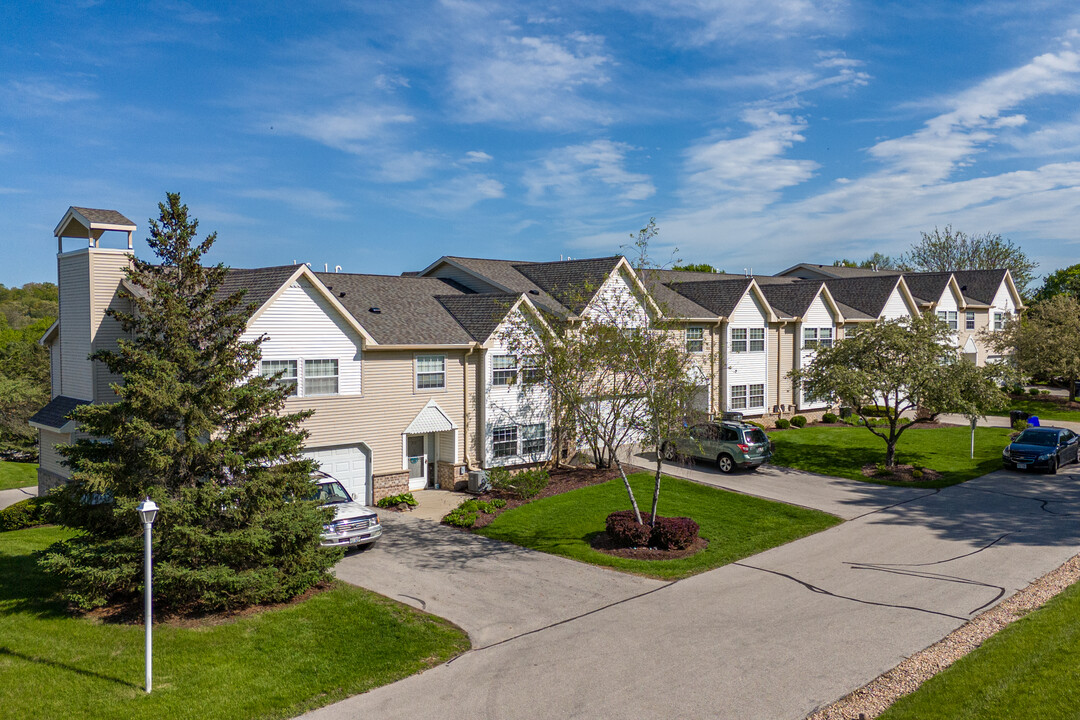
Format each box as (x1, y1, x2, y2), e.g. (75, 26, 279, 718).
(0, 528, 469, 719)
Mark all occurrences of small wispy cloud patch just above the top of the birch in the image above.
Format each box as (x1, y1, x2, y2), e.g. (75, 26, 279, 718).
(522, 139, 657, 204)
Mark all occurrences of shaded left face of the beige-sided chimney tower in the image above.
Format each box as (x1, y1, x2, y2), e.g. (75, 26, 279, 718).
(57, 248, 94, 400)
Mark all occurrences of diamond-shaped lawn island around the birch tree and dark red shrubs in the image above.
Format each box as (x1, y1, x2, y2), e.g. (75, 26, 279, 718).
(477, 473, 840, 580)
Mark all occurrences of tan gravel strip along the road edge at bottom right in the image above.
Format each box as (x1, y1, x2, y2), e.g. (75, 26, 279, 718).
(807, 555, 1080, 720)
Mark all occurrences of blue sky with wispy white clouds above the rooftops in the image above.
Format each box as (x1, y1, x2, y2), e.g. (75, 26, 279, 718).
(0, 0, 1080, 285)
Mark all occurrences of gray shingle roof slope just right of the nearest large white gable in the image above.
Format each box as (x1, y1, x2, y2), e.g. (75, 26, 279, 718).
(315, 272, 473, 345)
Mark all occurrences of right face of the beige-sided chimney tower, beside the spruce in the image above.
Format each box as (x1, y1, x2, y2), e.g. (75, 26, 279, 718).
(90, 249, 131, 403)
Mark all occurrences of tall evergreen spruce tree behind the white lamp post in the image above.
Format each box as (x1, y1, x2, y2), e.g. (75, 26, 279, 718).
(42, 193, 340, 612)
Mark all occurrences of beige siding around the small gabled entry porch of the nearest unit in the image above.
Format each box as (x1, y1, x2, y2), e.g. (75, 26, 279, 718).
(285, 351, 464, 475)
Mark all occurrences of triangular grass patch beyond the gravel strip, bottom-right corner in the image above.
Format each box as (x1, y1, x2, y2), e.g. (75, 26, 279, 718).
(881, 585, 1080, 720)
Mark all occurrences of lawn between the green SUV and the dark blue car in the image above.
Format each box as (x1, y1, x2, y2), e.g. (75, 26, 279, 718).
(769, 427, 1012, 488)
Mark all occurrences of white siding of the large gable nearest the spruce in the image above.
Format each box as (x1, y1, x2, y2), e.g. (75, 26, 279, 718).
(243, 279, 363, 395)
